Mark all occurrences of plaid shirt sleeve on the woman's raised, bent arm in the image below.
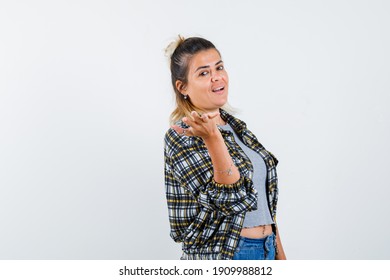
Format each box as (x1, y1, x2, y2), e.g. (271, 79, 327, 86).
(165, 130, 257, 216)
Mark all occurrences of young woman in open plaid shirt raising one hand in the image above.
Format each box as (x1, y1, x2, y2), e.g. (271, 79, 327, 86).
(164, 37, 286, 260)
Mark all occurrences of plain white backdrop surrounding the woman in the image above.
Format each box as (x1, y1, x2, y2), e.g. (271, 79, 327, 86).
(0, 0, 390, 259)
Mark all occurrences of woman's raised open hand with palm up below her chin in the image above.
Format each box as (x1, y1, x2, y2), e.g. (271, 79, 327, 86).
(172, 111, 219, 140)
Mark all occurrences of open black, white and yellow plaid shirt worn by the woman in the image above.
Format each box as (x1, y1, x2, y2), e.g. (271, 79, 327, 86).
(164, 110, 278, 260)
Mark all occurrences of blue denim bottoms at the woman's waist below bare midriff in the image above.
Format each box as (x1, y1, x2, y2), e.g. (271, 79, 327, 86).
(233, 233, 275, 260)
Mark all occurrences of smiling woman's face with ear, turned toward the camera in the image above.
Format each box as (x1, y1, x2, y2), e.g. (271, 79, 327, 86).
(176, 49, 229, 113)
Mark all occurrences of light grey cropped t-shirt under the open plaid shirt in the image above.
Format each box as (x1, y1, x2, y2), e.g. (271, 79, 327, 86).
(220, 124, 274, 227)
